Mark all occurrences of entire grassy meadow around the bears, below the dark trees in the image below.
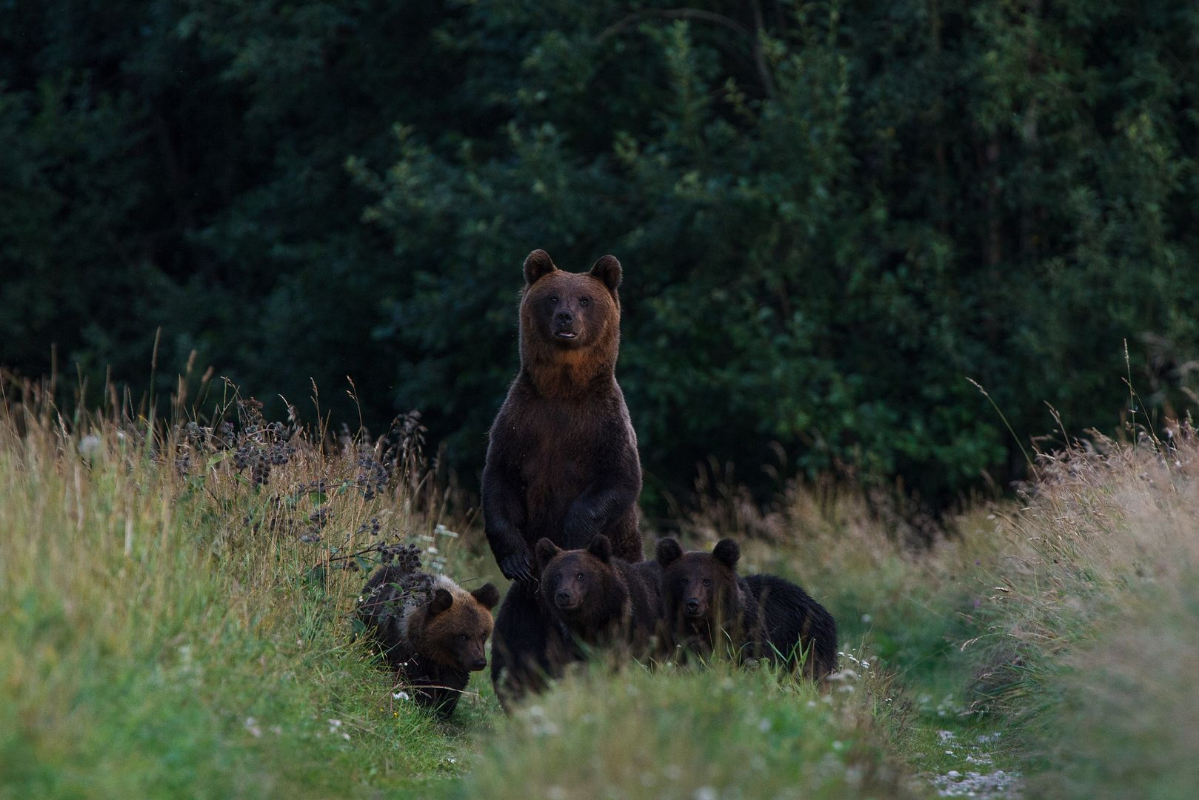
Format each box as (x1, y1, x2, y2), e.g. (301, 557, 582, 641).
(0, 376, 1199, 800)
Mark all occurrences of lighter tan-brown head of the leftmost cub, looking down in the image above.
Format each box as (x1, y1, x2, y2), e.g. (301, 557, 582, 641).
(409, 577, 500, 672)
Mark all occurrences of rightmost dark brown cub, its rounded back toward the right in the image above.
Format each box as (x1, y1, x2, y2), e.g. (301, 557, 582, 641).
(657, 539, 837, 680)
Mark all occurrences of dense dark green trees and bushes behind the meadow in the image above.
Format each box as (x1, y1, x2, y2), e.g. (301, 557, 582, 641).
(0, 0, 1199, 503)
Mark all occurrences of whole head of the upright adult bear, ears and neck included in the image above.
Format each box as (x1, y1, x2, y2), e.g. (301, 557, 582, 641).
(520, 249, 621, 391)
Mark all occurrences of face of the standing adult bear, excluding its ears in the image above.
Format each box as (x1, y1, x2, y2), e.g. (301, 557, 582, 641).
(520, 270, 619, 349)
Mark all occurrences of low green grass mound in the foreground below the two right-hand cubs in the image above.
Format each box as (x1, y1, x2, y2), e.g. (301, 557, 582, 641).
(459, 664, 921, 800)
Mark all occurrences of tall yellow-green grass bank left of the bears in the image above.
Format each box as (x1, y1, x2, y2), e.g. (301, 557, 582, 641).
(0, 386, 494, 798)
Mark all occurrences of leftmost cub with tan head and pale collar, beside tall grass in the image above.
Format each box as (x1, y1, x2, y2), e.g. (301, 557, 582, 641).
(359, 564, 500, 717)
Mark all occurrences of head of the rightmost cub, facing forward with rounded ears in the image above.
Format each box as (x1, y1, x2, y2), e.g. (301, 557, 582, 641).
(657, 539, 742, 631)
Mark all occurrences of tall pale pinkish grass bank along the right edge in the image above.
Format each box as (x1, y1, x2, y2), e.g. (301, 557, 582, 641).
(980, 426, 1199, 799)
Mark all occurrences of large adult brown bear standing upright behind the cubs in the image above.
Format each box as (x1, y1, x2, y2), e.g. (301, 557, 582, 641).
(483, 249, 641, 705)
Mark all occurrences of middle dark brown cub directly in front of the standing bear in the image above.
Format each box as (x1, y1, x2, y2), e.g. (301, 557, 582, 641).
(536, 534, 662, 657)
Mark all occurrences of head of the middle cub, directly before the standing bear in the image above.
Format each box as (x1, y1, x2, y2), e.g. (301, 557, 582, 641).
(535, 534, 628, 631)
